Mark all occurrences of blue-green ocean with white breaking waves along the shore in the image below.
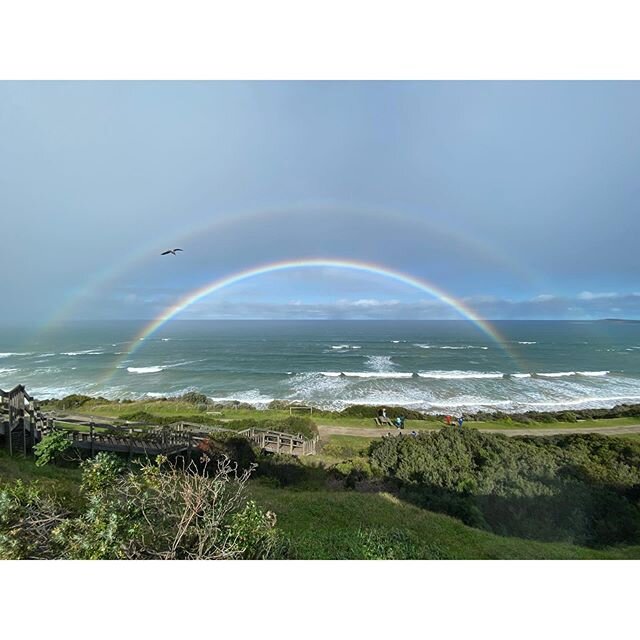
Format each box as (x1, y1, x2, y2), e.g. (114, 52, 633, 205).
(0, 320, 640, 413)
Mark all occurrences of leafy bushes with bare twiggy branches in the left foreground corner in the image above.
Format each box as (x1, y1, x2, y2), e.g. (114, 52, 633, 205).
(0, 453, 282, 559)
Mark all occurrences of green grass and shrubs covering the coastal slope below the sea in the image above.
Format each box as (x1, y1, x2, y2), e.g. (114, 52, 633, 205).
(0, 392, 640, 559)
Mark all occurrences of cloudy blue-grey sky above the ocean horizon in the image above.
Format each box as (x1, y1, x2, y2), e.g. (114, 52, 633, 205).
(0, 81, 640, 326)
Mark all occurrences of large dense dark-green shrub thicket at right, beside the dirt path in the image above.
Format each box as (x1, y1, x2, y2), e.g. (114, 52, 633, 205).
(369, 429, 640, 545)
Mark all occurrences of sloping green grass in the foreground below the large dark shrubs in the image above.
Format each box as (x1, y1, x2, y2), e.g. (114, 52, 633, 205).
(249, 481, 640, 559)
